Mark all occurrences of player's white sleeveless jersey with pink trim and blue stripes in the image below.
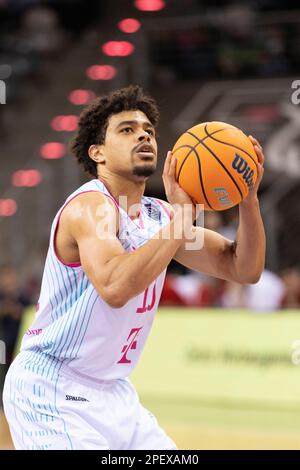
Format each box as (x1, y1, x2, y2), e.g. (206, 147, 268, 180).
(21, 179, 170, 380)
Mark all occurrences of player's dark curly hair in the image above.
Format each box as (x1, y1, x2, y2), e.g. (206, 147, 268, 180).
(70, 85, 159, 178)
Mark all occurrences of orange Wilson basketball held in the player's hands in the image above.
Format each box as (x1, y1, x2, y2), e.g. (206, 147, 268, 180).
(173, 122, 258, 211)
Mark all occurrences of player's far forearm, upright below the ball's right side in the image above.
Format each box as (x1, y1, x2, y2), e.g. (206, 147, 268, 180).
(233, 198, 266, 284)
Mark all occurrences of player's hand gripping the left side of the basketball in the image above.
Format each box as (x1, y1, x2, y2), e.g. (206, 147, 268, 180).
(162, 151, 196, 216)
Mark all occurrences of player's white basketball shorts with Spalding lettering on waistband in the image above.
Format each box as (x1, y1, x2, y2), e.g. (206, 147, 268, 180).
(3, 352, 176, 450)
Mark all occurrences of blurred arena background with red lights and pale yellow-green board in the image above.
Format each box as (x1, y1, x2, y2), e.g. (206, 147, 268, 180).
(0, 0, 300, 449)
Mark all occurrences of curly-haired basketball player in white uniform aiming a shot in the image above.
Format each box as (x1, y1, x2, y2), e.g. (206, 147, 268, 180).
(4, 86, 265, 450)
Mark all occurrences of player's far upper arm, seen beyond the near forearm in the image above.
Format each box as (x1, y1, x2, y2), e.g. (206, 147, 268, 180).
(174, 227, 237, 281)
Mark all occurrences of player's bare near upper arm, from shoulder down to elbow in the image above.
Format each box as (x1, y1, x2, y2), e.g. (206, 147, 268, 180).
(68, 193, 126, 307)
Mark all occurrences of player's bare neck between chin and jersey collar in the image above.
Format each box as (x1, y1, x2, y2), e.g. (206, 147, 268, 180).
(98, 175, 146, 218)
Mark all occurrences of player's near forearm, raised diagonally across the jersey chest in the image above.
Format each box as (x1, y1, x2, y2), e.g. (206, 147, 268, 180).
(102, 209, 193, 304)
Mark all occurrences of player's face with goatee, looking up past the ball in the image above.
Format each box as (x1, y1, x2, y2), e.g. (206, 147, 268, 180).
(102, 110, 157, 179)
